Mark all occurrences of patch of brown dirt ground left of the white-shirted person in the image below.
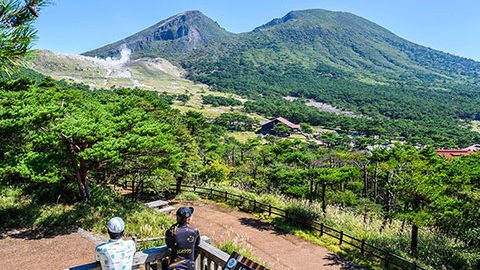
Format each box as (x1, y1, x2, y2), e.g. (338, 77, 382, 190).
(0, 230, 95, 270)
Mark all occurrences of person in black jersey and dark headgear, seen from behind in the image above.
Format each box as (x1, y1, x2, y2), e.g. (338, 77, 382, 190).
(165, 207, 200, 270)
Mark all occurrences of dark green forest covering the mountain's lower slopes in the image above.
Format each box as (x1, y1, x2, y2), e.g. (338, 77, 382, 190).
(192, 55, 480, 147)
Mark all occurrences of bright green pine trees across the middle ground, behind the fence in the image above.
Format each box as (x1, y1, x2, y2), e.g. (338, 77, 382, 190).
(0, 76, 480, 269)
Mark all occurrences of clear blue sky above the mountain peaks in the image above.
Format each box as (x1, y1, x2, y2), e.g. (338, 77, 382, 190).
(34, 0, 480, 61)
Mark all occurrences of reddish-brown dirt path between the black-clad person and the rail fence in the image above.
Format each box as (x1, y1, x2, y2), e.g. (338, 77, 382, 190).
(175, 201, 354, 270)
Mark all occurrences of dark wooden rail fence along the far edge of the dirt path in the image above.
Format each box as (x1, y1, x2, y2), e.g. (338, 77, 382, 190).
(175, 185, 427, 270)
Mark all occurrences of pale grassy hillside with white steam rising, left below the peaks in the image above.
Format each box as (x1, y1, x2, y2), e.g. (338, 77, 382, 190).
(32, 51, 264, 120)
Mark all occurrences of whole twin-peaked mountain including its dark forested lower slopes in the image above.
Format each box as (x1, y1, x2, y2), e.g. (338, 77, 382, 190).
(86, 9, 480, 144)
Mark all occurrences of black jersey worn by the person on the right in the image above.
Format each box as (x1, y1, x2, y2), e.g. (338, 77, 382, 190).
(165, 225, 200, 270)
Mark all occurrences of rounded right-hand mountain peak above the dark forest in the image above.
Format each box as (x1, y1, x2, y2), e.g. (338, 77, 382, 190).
(254, 9, 480, 81)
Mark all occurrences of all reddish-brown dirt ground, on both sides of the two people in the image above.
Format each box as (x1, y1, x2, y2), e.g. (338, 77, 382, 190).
(0, 201, 356, 270)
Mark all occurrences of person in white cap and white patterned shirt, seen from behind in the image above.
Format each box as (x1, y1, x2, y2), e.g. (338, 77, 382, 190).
(95, 217, 135, 270)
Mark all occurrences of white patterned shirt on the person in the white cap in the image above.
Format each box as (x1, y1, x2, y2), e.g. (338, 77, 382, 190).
(95, 239, 135, 270)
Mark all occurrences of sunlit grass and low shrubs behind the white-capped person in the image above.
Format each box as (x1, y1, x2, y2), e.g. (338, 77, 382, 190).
(0, 186, 175, 238)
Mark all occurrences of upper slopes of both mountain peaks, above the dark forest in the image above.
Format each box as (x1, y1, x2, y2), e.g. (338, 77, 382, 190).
(85, 9, 480, 82)
